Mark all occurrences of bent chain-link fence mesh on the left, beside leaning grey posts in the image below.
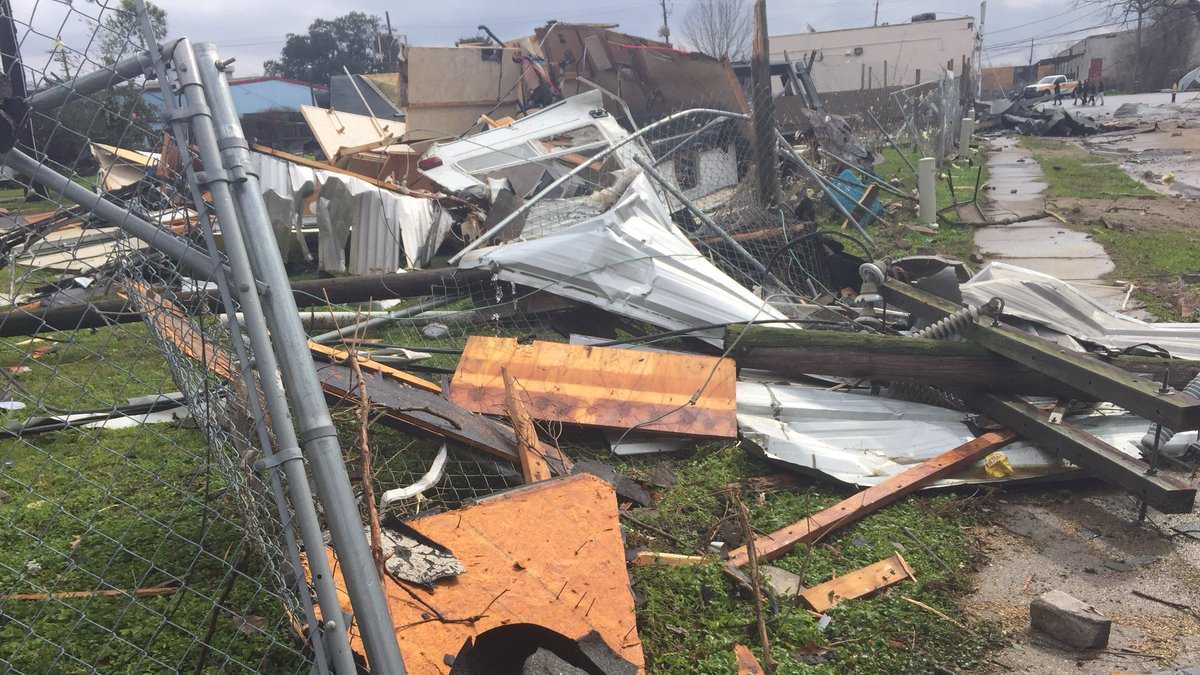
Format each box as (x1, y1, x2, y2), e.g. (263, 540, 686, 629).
(0, 0, 402, 673)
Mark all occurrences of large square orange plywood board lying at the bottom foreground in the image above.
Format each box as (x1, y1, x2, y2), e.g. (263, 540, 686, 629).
(316, 474, 644, 675)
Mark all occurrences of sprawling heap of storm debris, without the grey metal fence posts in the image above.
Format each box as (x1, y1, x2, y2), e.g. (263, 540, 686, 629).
(0, 18, 1200, 674)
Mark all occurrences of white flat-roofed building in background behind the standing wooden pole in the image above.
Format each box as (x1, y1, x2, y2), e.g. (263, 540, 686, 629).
(770, 17, 977, 94)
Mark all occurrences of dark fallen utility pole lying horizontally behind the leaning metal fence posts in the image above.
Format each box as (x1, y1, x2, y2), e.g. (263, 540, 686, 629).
(0, 268, 492, 338)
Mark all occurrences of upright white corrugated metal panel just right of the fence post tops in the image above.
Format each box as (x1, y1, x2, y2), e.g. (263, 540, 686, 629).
(250, 153, 452, 269)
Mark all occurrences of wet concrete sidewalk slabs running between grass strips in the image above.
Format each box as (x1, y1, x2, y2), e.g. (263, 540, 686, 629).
(974, 137, 1127, 309)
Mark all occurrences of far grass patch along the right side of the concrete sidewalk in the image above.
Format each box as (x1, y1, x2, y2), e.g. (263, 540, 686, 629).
(1020, 136, 1159, 199)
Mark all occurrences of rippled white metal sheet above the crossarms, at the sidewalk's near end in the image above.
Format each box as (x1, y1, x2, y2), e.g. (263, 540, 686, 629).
(962, 263, 1200, 359)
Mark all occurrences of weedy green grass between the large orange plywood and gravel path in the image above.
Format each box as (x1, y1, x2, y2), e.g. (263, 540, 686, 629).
(628, 446, 1001, 675)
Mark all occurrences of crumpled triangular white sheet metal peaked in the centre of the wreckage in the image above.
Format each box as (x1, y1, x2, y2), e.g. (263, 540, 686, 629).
(458, 175, 787, 345)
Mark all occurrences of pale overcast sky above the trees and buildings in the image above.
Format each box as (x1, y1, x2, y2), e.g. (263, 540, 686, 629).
(12, 0, 1112, 76)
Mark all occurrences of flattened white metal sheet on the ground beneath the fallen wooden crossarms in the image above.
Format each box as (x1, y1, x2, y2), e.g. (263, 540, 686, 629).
(738, 382, 1196, 486)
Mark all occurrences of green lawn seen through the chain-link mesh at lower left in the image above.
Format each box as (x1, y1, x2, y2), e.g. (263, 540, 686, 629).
(0, 323, 304, 673)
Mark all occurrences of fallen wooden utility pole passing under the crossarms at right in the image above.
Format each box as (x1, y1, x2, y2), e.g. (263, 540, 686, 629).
(725, 324, 1200, 401)
